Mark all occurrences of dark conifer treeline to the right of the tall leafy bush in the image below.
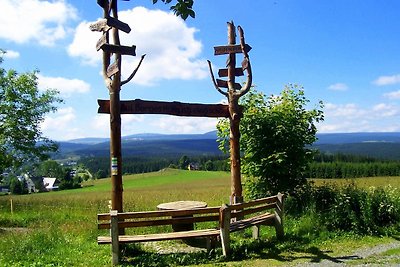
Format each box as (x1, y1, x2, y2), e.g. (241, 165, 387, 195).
(305, 154, 400, 178)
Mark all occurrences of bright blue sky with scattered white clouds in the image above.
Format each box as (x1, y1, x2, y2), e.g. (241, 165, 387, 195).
(0, 0, 400, 141)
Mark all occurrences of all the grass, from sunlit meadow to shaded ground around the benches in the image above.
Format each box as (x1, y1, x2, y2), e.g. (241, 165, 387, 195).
(0, 169, 400, 266)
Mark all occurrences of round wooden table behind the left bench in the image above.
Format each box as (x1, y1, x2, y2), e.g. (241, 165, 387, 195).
(157, 200, 207, 232)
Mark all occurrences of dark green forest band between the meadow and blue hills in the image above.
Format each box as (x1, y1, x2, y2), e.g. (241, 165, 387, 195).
(78, 153, 400, 179)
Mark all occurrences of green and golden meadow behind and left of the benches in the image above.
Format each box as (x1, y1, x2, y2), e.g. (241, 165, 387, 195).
(0, 169, 400, 266)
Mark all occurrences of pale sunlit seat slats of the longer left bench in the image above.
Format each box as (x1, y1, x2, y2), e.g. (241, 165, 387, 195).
(97, 229, 220, 244)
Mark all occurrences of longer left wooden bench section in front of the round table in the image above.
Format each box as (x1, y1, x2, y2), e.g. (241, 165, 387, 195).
(97, 207, 220, 264)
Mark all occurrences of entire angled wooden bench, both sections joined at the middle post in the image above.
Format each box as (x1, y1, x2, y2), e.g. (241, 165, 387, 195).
(97, 193, 284, 264)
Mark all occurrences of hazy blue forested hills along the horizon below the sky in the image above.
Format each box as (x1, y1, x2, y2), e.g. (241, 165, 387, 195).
(55, 131, 400, 160)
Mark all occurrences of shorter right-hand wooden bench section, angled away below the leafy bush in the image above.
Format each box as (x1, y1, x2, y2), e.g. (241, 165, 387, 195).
(220, 193, 284, 256)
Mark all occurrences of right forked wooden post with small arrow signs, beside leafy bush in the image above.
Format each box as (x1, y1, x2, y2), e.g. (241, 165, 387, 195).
(208, 22, 252, 203)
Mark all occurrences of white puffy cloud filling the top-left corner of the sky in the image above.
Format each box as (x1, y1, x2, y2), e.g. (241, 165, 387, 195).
(0, 0, 77, 46)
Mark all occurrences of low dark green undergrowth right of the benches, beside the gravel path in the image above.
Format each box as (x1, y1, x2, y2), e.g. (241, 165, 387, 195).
(286, 183, 400, 235)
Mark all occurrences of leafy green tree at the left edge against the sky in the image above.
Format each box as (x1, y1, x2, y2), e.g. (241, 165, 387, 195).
(0, 50, 62, 173)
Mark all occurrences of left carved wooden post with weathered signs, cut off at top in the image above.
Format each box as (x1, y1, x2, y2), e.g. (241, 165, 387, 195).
(90, 0, 144, 222)
